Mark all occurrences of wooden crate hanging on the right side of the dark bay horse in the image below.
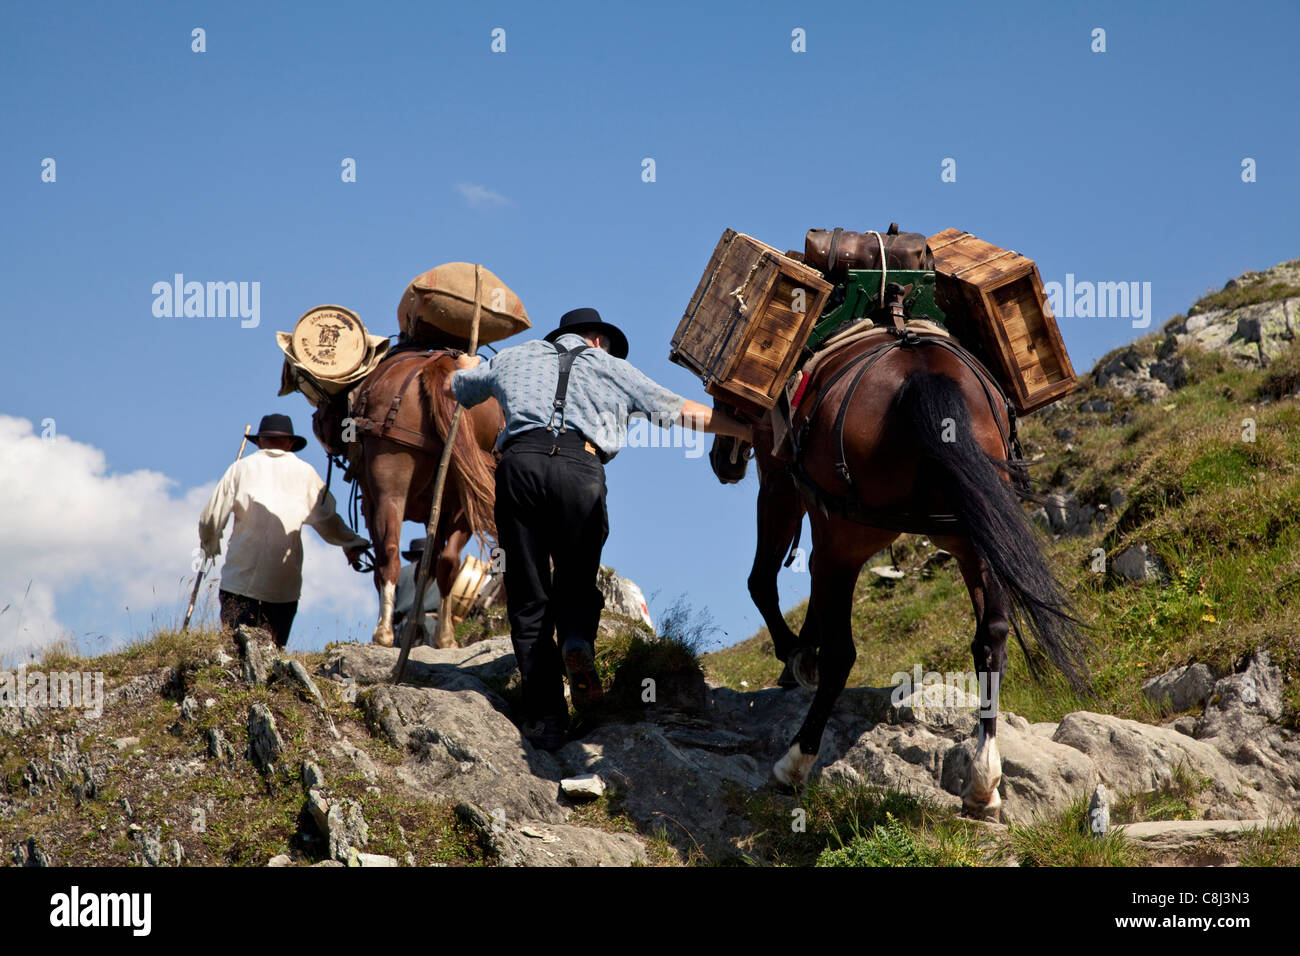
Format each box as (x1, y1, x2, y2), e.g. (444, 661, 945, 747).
(930, 229, 1075, 415)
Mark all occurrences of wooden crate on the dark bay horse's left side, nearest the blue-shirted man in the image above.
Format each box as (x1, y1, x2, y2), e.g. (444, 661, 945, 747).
(668, 229, 832, 412)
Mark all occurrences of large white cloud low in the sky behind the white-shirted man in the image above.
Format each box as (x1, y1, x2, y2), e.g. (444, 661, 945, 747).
(0, 415, 376, 661)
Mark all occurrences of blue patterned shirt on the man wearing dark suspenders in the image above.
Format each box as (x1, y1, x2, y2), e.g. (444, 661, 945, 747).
(451, 333, 685, 458)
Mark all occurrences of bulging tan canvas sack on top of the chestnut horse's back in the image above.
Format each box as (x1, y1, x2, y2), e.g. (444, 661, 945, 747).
(398, 263, 533, 349)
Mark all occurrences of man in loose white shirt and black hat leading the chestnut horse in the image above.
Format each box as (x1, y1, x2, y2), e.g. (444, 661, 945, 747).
(199, 415, 371, 648)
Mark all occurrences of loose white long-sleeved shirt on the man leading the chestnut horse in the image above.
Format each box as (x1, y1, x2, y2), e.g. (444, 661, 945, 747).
(199, 449, 369, 604)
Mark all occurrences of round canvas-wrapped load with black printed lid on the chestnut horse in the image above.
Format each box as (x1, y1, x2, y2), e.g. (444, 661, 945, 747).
(276, 306, 389, 406)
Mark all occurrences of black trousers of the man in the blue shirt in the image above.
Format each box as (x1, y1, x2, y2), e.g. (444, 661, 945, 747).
(495, 429, 610, 721)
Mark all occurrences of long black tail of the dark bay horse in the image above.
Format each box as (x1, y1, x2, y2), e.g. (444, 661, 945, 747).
(894, 371, 1091, 693)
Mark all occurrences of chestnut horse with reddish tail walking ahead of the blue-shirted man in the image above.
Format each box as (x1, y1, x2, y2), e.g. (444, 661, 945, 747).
(350, 350, 506, 648)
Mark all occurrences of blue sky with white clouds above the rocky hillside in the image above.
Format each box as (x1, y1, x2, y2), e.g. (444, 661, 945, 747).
(0, 1, 1300, 652)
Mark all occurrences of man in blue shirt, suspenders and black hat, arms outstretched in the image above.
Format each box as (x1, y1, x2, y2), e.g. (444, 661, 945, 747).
(447, 308, 753, 749)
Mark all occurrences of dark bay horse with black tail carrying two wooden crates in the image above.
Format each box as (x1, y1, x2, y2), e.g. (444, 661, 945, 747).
(710, 329, 1087, 818)
